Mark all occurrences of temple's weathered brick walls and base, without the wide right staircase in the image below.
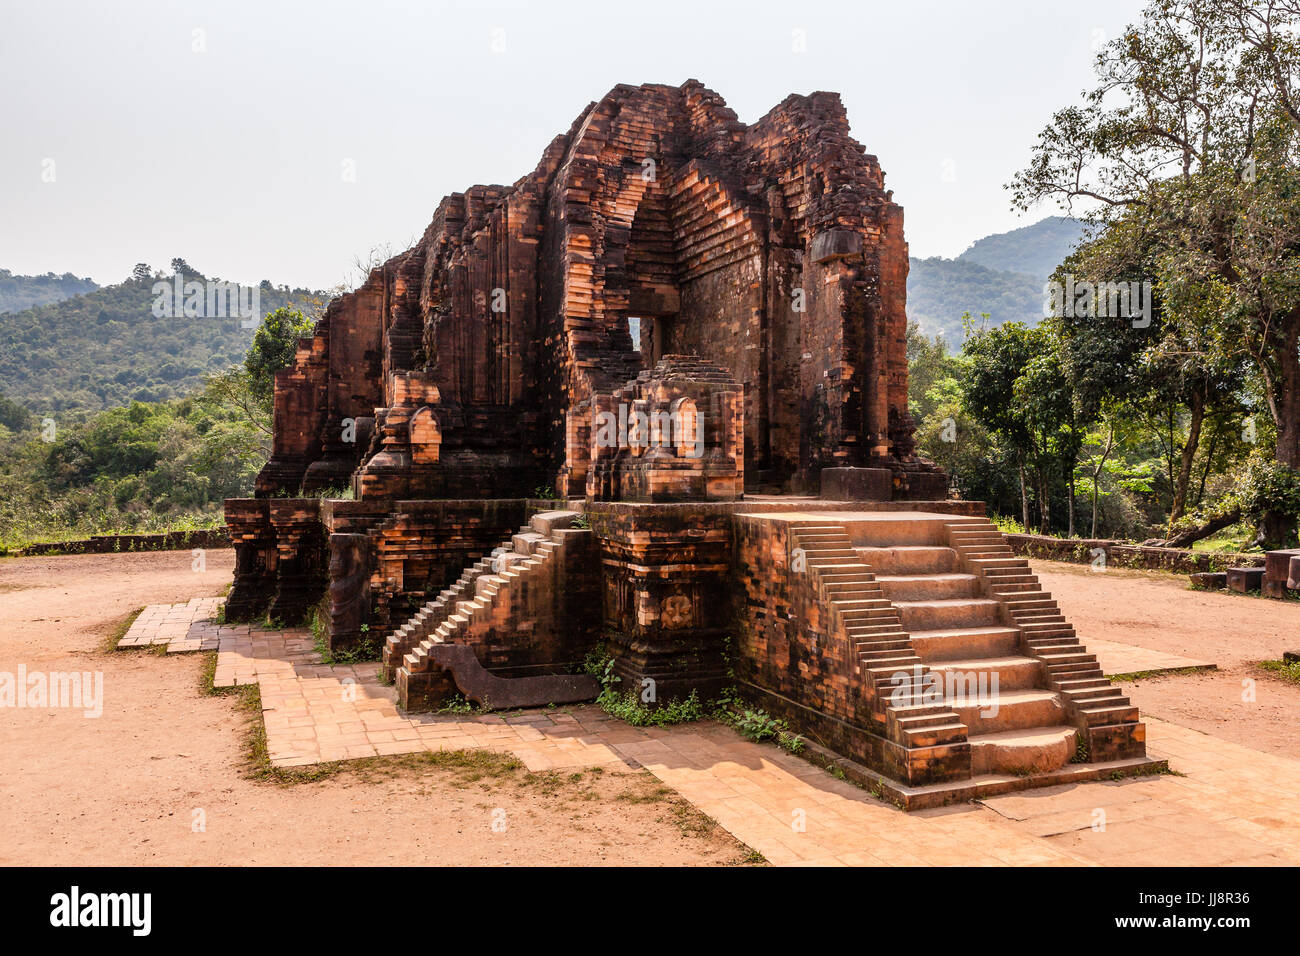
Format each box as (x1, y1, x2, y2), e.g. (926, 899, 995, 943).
(218, 81, 974, 780)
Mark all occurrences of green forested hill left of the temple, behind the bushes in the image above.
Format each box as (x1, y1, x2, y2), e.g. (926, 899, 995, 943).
(0, 259, 329, 414)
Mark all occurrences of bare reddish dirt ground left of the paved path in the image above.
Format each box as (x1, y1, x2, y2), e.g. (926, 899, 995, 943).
(0, 550, 749, 865)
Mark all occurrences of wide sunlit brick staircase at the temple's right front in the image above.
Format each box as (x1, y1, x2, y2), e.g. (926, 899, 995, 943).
(792, 514, 1145, 790)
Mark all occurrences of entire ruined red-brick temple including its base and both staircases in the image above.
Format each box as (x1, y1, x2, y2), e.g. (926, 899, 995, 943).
(226, 81, 1159, 805)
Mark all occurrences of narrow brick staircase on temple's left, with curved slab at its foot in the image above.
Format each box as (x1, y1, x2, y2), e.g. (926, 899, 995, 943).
(384, 511, 599, 711)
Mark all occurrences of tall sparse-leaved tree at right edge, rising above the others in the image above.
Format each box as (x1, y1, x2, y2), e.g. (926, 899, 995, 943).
(1011, 0, 1300, 541)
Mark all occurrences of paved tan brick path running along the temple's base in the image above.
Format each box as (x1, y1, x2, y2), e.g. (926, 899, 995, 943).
(126, 601, 1300, 866)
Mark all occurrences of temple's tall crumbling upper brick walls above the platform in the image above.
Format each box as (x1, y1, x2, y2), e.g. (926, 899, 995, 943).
(245, 81, 946, 498)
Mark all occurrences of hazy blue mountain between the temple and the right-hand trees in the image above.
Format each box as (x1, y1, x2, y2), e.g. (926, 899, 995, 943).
(907, 216, 1086, 345)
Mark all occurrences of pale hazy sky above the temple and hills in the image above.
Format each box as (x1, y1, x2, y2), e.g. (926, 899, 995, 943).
(0, 0, 1141, 287)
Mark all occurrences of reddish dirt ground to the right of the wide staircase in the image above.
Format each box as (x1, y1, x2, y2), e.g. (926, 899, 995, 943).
(1031, 561, 1300, 758)
